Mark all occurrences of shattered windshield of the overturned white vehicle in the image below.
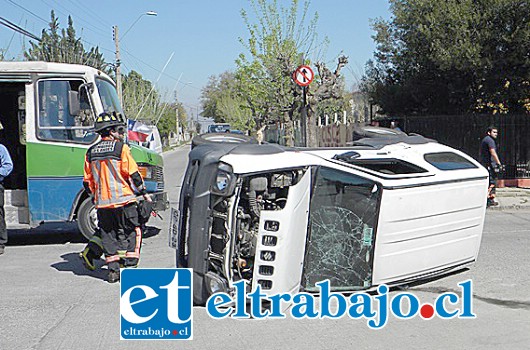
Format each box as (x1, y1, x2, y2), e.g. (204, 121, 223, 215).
(304, 167, 380, 291)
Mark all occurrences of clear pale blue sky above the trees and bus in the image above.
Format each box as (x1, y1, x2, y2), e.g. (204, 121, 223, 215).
(0, 0, 390, 115)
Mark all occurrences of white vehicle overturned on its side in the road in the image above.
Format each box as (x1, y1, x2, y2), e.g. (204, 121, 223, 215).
(170, 131, 488, 304)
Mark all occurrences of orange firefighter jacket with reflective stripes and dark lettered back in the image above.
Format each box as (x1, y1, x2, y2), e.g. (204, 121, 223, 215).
(83, 137, 138, 208)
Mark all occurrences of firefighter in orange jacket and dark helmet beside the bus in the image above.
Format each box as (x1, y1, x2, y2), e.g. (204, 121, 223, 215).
(81, 113, 151, 283)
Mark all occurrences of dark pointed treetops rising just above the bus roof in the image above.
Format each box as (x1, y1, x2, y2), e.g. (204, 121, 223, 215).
(24, 10, 110, 73)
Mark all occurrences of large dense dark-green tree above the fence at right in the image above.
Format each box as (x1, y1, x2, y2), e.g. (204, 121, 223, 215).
(363, 0, 530, 114)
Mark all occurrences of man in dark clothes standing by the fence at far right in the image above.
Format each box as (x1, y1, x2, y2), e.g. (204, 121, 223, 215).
(480, 126, 501, 207)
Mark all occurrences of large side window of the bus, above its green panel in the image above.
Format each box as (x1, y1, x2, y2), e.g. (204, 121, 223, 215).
(37, 80, 97, 144)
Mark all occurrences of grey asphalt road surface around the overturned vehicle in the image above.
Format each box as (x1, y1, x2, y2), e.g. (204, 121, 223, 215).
(0, 147, 530, 350)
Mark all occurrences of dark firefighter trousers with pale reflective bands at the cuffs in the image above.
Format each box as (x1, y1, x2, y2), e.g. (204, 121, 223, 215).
(97, 203, 142, 271)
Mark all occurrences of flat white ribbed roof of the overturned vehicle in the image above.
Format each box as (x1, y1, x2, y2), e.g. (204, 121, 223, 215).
(373, 179, 488, 284)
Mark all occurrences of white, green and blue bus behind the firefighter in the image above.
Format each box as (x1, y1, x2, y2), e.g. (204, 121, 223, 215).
(0, 62, 167, 238)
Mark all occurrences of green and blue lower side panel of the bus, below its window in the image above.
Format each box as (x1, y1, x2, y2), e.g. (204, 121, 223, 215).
(26, 142, 87, 223)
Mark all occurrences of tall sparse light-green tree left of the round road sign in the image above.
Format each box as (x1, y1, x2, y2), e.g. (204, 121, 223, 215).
(236, 0, 318, 145)
